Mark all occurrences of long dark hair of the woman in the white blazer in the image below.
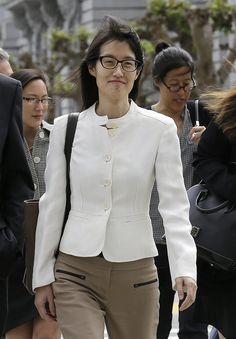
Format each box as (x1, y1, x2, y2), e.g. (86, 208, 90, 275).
(79, 16, 143, 109)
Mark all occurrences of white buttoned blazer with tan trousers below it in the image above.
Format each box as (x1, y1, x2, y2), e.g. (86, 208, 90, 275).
(33, 101, 196, 288)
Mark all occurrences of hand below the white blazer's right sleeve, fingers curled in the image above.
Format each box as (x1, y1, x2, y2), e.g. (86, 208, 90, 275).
(175, 277, 197, 311)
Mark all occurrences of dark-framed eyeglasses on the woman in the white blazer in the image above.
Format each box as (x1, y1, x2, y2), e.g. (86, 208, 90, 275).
(99, 55, 142, 72)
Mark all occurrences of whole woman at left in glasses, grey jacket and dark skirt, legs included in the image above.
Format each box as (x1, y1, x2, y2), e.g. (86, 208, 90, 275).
(3, 69, 60, 339)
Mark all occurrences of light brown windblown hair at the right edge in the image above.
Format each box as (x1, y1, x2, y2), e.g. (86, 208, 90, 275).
(201, 85, 236, 143)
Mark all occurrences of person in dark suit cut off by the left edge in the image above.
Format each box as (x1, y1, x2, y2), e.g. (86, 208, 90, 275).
(0, 74, 33, 336)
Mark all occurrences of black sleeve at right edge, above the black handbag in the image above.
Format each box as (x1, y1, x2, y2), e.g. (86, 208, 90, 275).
(193, 121, 236, 202)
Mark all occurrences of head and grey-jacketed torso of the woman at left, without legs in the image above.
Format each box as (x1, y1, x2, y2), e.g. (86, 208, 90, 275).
(11, 69, 52, 199)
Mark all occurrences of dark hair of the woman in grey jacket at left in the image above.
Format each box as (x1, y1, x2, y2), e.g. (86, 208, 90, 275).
(11, 68, 47, 88)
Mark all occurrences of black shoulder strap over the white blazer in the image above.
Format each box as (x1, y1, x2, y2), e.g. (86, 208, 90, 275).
(58, 113, 79, 254)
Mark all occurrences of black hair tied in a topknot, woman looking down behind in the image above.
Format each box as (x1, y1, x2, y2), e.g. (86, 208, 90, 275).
(152, 41, 194, 80)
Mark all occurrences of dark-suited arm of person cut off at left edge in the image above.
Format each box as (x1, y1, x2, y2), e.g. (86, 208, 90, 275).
(1, 79, 33, 250)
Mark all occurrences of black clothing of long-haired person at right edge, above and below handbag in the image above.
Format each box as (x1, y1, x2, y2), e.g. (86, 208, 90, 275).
(193, 117, 236, 339)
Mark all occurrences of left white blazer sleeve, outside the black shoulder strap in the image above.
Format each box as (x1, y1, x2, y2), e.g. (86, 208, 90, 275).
(33, 115, 67, 289)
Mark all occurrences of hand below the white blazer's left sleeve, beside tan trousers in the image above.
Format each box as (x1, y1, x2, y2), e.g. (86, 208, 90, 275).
(34, 285, 56, 321)
